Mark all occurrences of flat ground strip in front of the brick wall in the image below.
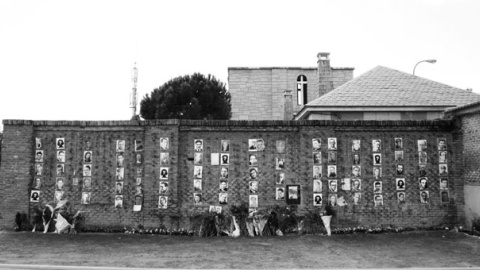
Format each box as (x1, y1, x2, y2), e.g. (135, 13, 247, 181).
(0, 231, 480, 268)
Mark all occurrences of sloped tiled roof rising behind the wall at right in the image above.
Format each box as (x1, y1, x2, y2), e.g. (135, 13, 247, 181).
(305, 66, 480, 107)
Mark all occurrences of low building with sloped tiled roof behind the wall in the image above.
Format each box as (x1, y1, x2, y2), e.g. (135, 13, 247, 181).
(295, 66, 480, 120)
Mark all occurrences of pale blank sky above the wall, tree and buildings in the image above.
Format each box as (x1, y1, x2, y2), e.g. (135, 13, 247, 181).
(0, 0, 480, 130)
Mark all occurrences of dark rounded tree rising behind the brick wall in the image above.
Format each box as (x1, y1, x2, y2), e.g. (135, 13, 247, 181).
(140, 73, 232, 120)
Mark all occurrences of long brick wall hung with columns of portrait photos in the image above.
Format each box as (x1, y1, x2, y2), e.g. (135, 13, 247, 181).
(0, 120, 465, 229)
